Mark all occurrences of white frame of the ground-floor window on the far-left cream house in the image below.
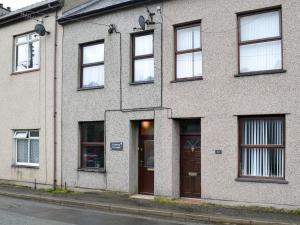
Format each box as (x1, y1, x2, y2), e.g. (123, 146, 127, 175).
(13, 130, 40, 167)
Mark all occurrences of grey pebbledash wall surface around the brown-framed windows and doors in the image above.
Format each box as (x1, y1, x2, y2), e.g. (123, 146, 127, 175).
(62, 0, 300, 206)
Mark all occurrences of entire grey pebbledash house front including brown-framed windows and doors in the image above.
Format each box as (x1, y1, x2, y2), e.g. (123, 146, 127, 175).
(59, 0, 300, 206)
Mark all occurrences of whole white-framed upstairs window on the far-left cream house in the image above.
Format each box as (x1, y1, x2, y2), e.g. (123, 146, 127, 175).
(14, 33, 40, 72)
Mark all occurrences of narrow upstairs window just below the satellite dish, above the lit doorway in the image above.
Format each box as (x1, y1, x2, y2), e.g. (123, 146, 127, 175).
(133, 33, 154, 83)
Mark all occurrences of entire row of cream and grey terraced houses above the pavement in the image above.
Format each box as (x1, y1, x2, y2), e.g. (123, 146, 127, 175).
(0, 0, 300, 207)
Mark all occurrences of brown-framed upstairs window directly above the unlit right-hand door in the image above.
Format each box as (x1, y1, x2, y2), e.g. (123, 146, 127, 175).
(175, 24, 202, 79)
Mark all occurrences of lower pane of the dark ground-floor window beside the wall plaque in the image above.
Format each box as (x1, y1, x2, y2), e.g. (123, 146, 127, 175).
(81, 146, 104, 168)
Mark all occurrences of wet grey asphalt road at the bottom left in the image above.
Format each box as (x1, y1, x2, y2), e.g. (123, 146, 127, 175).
(0, 197, 212, 225)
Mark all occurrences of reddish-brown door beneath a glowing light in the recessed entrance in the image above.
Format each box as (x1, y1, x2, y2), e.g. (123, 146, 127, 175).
(139, 121, 154, 195)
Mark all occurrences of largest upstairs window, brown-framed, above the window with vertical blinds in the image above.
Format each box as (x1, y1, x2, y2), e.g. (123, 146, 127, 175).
(239, 9, 283, 75)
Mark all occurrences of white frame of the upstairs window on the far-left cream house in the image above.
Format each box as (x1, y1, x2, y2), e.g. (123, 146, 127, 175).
(13, 32, 41, 73)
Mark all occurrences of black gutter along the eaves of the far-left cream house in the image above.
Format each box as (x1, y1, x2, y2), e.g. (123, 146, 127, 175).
(0, 0, 63, 27)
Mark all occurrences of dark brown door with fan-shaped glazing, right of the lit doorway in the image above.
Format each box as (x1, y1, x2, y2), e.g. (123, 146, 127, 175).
(180, 135, 201, 198)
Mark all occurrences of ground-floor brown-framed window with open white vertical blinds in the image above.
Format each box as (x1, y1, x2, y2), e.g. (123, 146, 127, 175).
(239, 116, 285, 179)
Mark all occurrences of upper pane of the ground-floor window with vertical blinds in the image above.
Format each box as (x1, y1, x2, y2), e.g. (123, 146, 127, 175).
(242, 119, 283, 145)
